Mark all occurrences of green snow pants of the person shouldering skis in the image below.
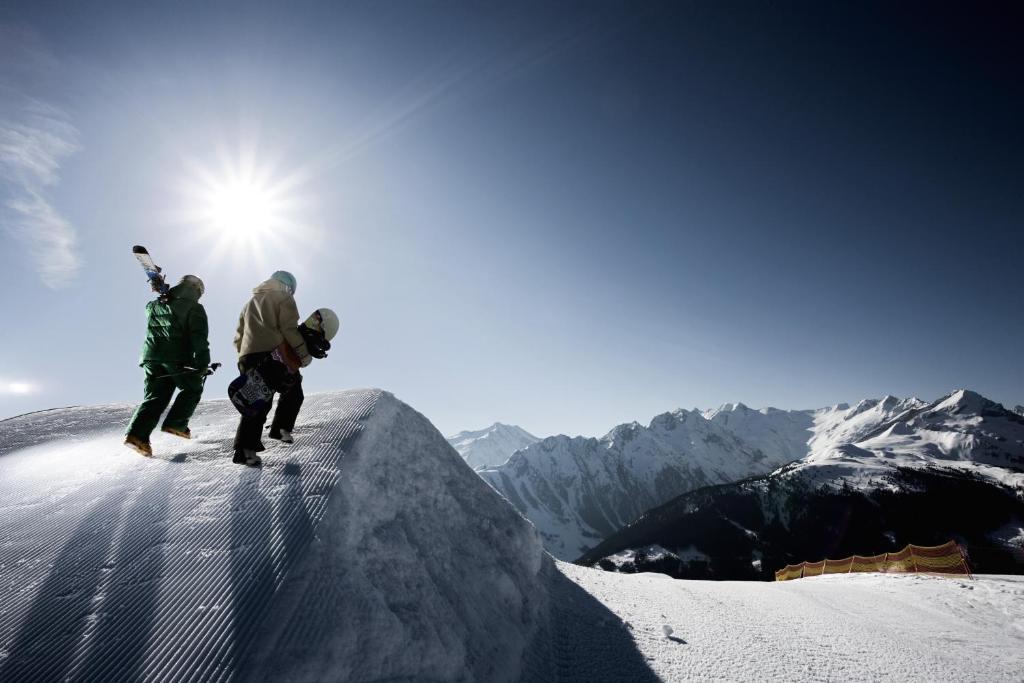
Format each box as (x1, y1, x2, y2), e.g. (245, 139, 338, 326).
(128, 362, 203, 441)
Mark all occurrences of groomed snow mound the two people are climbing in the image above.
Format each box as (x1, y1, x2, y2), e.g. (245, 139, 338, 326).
(0, 390, 650, 681)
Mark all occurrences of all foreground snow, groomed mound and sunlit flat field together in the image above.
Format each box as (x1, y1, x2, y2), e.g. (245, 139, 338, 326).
(0, 390, 1024, 683)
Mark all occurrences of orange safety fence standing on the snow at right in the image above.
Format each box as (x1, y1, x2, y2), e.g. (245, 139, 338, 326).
(775, 541, 971, 581)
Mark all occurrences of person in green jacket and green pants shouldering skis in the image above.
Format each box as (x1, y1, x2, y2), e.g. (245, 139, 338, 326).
(125, 275, 210, 456)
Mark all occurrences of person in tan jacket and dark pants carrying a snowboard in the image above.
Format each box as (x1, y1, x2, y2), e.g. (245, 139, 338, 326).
(233, 270, 312, 466)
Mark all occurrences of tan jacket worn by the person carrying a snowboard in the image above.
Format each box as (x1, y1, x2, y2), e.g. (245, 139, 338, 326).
(234, 280, 312, 368)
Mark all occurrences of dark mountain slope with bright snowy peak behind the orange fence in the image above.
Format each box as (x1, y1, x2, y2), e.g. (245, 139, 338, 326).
(581, 389, 1024, 579)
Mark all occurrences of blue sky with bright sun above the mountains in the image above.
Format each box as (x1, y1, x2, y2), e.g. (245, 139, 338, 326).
(0, 1, 1024, 434)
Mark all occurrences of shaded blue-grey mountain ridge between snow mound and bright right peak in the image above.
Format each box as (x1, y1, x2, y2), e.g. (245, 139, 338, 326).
(480, 403, 813, 560)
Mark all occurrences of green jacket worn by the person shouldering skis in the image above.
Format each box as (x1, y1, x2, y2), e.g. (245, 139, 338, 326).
(139, 283, 210, 369)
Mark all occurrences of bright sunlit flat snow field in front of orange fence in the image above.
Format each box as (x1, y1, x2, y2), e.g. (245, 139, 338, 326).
(558, 562, 1024, 681)
